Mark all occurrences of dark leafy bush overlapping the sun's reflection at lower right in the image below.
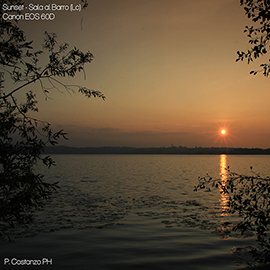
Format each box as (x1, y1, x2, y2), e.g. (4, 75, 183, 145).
(194, 167, 270, 263)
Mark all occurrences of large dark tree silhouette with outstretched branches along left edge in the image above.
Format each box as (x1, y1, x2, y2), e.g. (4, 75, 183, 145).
(0, 0, 105, 240)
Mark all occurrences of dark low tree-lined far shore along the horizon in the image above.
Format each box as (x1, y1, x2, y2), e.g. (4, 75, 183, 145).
(44, 146, 270, 155)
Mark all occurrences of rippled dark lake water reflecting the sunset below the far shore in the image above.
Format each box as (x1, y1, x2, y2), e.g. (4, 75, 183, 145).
(0, 155, 270, 270)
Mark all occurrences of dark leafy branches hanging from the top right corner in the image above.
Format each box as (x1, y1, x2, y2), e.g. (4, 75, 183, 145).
(236, 0, 270, 77)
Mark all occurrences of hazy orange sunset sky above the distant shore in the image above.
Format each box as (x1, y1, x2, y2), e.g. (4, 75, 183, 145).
(6, 0, 270, 148)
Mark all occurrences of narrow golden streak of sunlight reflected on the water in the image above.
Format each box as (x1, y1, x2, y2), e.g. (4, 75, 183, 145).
(219, 155, 229, 216)
